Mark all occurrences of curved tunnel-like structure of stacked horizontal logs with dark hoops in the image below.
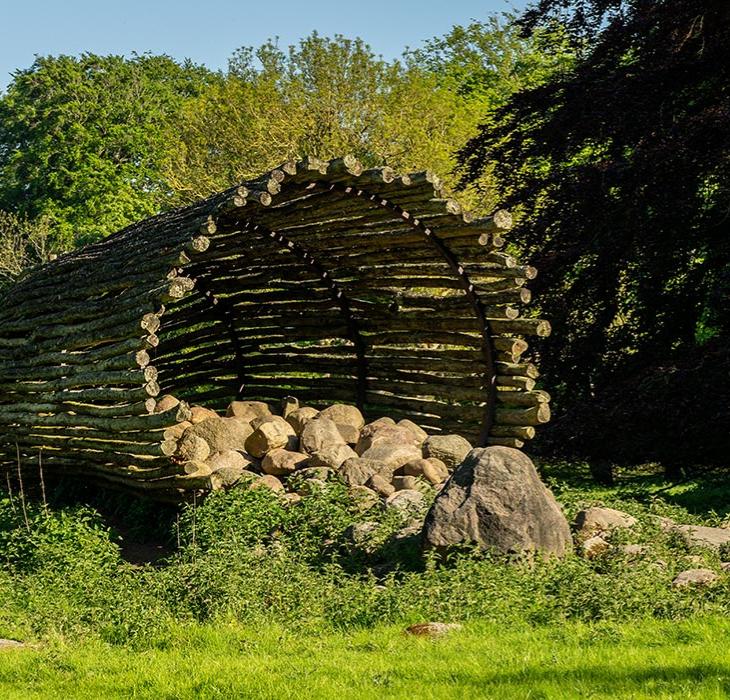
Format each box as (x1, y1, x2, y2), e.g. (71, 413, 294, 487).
(0, 157, 550, 492)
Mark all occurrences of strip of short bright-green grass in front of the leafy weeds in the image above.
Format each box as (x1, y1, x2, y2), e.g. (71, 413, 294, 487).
(0, 618, 730, 700)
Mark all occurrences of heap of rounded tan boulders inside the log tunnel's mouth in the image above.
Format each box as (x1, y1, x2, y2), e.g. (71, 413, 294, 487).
(155, 396, 472, 509)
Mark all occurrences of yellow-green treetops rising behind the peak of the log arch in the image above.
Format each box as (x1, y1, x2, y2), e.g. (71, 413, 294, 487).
(165, 26, 552, 208)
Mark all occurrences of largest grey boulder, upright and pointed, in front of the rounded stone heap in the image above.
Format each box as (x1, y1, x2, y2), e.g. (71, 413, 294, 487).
(423, 447, 572, 557)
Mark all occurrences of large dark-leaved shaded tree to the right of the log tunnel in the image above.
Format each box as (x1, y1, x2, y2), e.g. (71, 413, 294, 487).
(459, 0, 730, 470)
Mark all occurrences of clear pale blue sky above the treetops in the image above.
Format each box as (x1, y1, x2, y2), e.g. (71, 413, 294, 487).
(0, 0, 527, 90)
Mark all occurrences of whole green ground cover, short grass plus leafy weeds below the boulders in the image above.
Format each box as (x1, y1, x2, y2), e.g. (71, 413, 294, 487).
(0, 463, 730, 700)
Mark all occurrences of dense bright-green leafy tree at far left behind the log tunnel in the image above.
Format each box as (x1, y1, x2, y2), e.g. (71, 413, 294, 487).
(0, 54, 211, 246)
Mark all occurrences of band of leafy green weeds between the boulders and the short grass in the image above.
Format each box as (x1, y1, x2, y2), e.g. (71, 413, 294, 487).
(0, 468, 730, 647)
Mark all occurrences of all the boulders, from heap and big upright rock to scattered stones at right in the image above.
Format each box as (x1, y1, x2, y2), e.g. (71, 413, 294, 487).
(155, 396, 730, 588)
